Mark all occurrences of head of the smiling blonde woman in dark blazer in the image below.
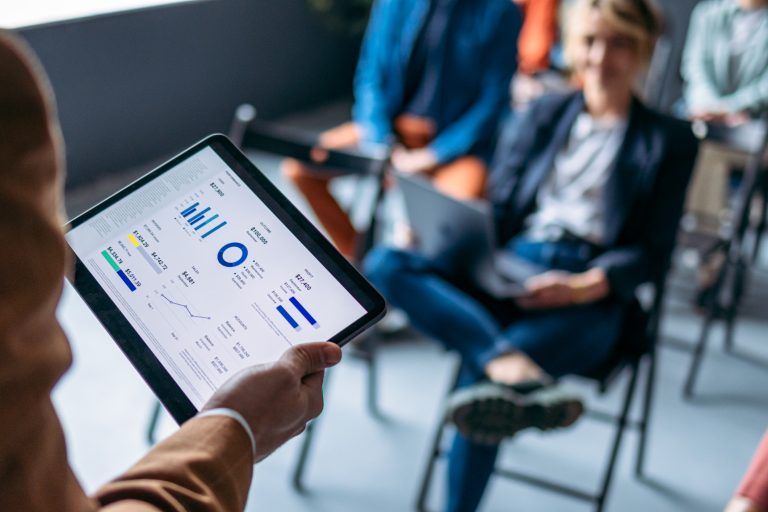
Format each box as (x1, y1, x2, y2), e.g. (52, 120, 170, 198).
(565, 0, 662, 99)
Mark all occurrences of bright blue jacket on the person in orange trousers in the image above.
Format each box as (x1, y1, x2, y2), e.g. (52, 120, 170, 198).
(352, 0, 522, 163)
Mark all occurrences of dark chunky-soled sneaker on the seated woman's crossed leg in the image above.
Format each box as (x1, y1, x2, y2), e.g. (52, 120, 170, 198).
(446, 382, 584, 444)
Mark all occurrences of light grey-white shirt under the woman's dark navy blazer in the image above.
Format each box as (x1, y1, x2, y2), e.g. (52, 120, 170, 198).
(525, 112, 627, 245)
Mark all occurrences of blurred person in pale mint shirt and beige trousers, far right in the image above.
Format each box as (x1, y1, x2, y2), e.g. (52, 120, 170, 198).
(675, 0, 768, 262)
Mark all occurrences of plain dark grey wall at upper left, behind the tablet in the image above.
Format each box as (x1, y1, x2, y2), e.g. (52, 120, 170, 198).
(21, 0, 358, 186)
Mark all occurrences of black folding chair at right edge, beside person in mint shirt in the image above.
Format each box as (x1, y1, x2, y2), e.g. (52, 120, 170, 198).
(683, 120, 768, 398)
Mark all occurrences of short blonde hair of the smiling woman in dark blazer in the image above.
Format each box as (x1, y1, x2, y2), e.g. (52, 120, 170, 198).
(564, 0, 663, 66)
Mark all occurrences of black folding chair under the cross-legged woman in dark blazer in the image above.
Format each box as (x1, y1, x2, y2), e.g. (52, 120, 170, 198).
(416, 279, 665, 512)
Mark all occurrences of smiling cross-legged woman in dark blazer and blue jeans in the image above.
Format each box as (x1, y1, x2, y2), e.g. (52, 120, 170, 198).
(365, 0, 697, 511)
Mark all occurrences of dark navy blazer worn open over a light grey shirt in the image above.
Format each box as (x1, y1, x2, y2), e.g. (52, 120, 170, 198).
(489, 92, 698, 300)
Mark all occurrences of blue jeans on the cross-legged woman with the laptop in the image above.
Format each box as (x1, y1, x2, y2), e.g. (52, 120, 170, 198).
(365, 238, 623, 512)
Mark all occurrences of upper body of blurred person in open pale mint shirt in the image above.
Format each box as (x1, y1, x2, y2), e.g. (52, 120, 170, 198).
(681, 0, 768, 124)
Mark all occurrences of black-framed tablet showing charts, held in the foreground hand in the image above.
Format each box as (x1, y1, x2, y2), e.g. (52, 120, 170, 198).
(66, 135, 385, 423)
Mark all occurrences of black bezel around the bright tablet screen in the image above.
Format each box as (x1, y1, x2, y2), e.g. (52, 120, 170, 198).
(65, 134, 386, 424)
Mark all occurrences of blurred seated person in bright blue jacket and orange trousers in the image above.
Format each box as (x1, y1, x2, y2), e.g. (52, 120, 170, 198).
(283, 0, 521, 259)
